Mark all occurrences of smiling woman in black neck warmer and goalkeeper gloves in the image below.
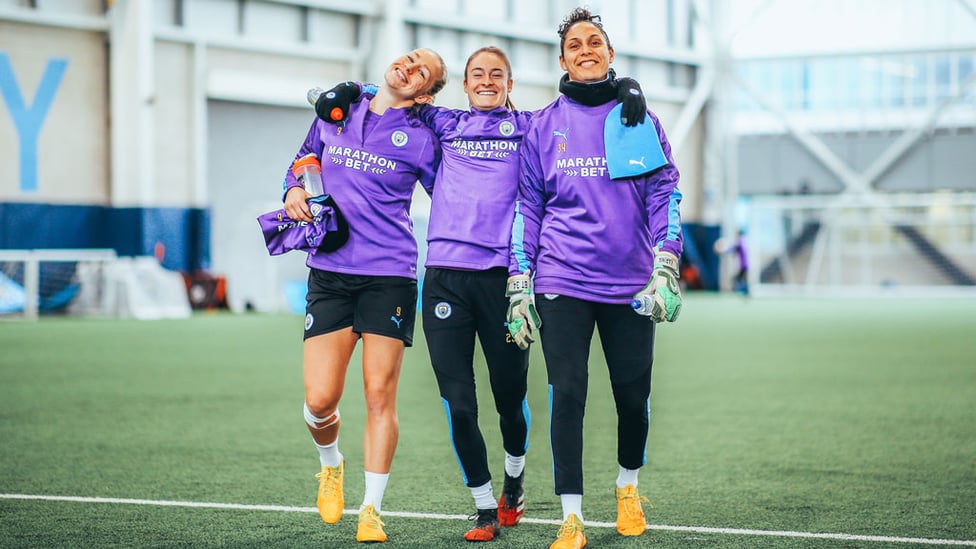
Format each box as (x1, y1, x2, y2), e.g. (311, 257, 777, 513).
(507, 8, 682, 549)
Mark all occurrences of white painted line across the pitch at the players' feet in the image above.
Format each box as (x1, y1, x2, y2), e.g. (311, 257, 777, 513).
(0, 494, 976, 547)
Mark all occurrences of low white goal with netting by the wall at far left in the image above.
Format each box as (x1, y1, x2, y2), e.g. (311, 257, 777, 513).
(0, 250, 191, 320)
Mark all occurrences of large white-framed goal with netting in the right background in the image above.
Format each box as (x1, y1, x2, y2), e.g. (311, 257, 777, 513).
(747, 193, 976, 297)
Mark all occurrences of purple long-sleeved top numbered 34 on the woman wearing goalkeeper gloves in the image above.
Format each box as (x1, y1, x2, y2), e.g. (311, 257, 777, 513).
(509, 96, 682, 304)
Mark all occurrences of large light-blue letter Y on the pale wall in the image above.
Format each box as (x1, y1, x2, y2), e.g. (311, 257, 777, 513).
(0, 52, 68, 193)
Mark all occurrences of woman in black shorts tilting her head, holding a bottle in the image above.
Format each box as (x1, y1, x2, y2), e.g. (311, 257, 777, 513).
(284, 49, 447, 542)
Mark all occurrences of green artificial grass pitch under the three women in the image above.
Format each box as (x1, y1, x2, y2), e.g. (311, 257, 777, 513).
(0, 294, 976, 549)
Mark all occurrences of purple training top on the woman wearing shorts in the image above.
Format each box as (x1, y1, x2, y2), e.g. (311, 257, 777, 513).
(285, 100, 440, 279)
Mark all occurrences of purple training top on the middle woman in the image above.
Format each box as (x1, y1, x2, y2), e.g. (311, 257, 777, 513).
(420, 107, 531, 270)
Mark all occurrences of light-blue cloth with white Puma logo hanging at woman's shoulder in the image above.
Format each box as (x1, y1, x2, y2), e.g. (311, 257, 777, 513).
(603, 104, 668, 179)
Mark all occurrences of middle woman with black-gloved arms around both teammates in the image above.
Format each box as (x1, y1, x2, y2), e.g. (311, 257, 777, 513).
(316, 46, 646, 541)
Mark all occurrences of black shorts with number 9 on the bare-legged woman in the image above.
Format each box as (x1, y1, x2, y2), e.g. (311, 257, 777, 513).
(304, 269, 417, 347)
